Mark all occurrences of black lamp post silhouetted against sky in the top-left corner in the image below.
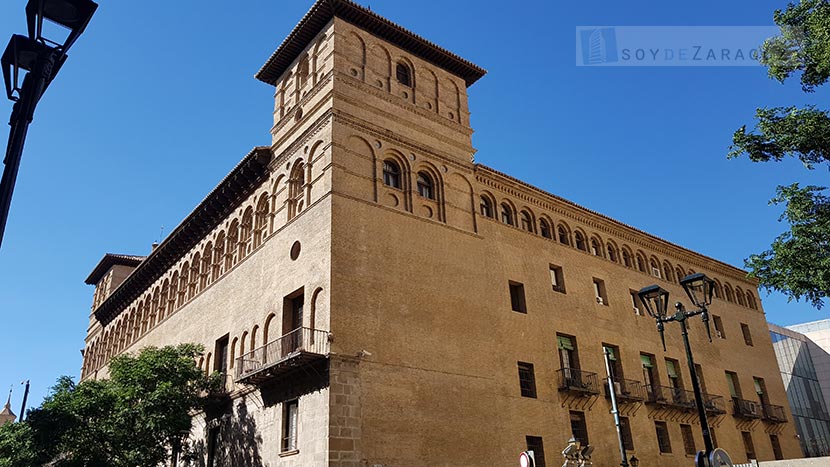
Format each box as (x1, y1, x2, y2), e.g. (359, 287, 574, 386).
(0, 0, 98, 249)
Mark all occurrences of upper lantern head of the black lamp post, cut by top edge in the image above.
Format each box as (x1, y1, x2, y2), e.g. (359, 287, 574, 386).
(26, 0, 98, 53)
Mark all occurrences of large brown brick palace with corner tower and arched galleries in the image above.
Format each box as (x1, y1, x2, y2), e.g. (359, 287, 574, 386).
(82, 0, 800, 467)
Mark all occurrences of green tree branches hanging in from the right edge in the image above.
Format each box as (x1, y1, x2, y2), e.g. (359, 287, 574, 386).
(729, 0, 830, 309)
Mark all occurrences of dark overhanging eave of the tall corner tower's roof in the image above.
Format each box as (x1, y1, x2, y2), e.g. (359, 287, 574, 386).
(255, 0, 487, 87)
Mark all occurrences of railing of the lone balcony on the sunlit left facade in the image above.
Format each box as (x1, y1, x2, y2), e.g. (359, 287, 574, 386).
(235, 328, 329, 384)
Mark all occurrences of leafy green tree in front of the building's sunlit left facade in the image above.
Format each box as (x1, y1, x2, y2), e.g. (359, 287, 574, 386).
(0, 344, 218, 467)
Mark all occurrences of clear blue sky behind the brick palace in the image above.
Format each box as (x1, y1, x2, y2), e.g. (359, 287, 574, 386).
(0, 0, 830, 412)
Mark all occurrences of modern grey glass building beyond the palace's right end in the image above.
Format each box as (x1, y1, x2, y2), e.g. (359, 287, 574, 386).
(769, 324, 830, 457)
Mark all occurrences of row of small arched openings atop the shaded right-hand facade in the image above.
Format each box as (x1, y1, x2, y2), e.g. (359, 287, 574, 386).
(479, 193, 758, 310)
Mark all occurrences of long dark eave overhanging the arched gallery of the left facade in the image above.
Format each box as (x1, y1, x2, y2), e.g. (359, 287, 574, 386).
(95, 146, 273, 326)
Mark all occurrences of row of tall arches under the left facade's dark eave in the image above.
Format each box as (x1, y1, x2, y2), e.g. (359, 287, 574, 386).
(82, 161, 307, 374)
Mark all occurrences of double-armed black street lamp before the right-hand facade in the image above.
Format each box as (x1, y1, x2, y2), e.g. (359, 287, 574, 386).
(637, 273, 732, 467)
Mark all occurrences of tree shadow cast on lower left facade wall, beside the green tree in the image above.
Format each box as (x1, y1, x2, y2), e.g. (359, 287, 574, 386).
(182, 397, 265, 467)
